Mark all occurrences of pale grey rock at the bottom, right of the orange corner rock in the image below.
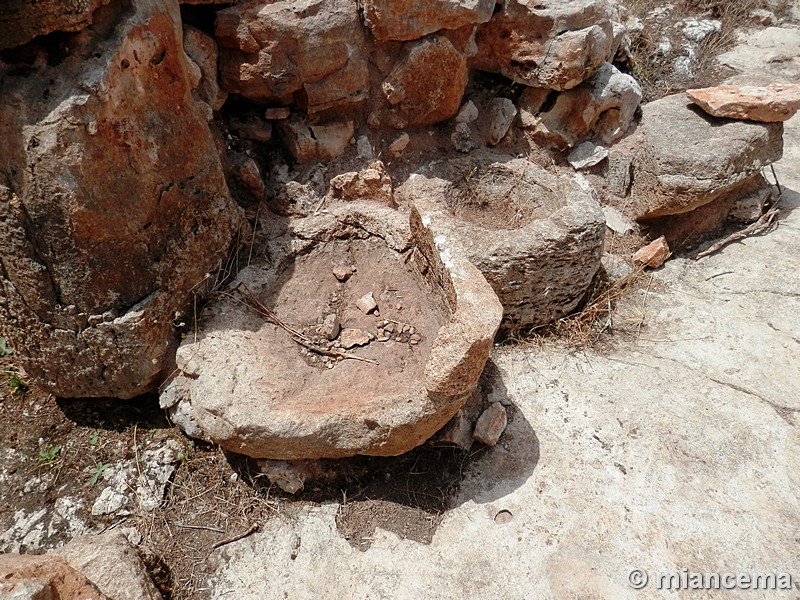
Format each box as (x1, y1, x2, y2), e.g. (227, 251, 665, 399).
(55, 531, 161, 600)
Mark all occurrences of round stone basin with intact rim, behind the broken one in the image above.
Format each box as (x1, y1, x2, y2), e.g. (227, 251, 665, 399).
(397, 154, 605, 328)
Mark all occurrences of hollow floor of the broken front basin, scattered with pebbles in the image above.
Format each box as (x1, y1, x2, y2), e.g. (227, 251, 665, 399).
(241, 234, 445, 412)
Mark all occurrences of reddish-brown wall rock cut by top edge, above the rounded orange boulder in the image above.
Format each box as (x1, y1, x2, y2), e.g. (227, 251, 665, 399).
(361, 0, 494, 41)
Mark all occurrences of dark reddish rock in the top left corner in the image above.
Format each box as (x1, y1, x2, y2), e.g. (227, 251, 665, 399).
(0, 0, 109, 50)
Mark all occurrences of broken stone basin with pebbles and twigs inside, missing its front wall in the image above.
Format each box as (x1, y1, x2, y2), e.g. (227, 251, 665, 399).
(161, 207, 502, 459)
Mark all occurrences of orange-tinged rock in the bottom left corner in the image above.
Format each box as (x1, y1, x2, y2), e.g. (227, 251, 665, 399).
(0, 554, 109, 600)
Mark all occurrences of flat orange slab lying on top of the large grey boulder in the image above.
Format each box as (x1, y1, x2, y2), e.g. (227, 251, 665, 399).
(686, 83, 800, 123)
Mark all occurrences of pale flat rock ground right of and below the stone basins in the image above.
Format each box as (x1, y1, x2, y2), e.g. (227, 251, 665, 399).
(208, 31, 800, 600)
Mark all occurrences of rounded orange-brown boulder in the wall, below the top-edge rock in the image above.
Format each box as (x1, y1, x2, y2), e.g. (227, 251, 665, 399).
(370, 35, 468, 129)
